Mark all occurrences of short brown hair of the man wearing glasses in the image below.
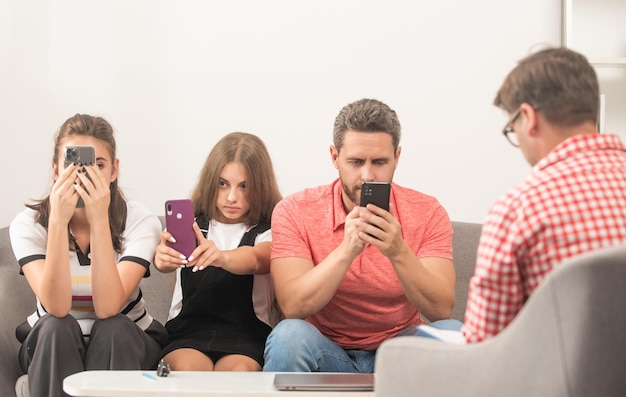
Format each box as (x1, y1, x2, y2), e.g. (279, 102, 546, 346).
(494, 47, 600, 126)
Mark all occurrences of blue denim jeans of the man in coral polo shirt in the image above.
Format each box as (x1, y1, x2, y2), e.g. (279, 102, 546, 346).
(263, 319, 460, 373)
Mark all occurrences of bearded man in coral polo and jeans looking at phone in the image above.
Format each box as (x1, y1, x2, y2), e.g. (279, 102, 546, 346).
(264, 99, 460, 372)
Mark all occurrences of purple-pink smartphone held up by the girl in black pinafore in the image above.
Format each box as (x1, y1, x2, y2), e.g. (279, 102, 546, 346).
(165, 199, 196, 258)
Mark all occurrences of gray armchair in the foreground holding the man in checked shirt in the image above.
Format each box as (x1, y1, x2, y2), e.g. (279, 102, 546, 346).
(375, 244, 626, 397)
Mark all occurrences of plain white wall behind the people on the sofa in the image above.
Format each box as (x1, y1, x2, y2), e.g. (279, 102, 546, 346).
(0, 0, 604, 226)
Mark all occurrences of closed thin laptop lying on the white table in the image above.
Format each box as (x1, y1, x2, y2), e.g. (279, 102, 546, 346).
(274, 372, 374, 391)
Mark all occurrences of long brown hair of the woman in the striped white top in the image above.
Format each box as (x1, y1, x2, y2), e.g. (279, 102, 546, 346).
(26, 114, 127, 252)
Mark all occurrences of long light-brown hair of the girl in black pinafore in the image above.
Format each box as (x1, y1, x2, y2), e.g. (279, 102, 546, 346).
(191, 132, 281, 225)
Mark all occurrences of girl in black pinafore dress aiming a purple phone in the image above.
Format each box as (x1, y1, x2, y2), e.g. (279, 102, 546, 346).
(155, 132, 281, 371)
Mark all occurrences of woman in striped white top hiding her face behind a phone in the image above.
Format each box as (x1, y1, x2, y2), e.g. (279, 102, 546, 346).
(10, 114, 167, 396)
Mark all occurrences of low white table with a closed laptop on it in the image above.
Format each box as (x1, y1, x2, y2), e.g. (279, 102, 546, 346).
(63, 371, 374, 397)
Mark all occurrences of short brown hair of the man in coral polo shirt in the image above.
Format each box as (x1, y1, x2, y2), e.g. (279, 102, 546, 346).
(333, 98, 400, 151)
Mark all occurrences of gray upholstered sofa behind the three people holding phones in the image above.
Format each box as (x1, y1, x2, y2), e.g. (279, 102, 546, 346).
(0, 218, 481, 396)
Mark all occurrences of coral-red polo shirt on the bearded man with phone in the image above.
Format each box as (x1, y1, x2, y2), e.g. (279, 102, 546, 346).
(272, 179, 452, 350)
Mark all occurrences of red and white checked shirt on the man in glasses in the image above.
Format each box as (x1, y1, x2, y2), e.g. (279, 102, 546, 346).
(463, 134, 626, 342)
